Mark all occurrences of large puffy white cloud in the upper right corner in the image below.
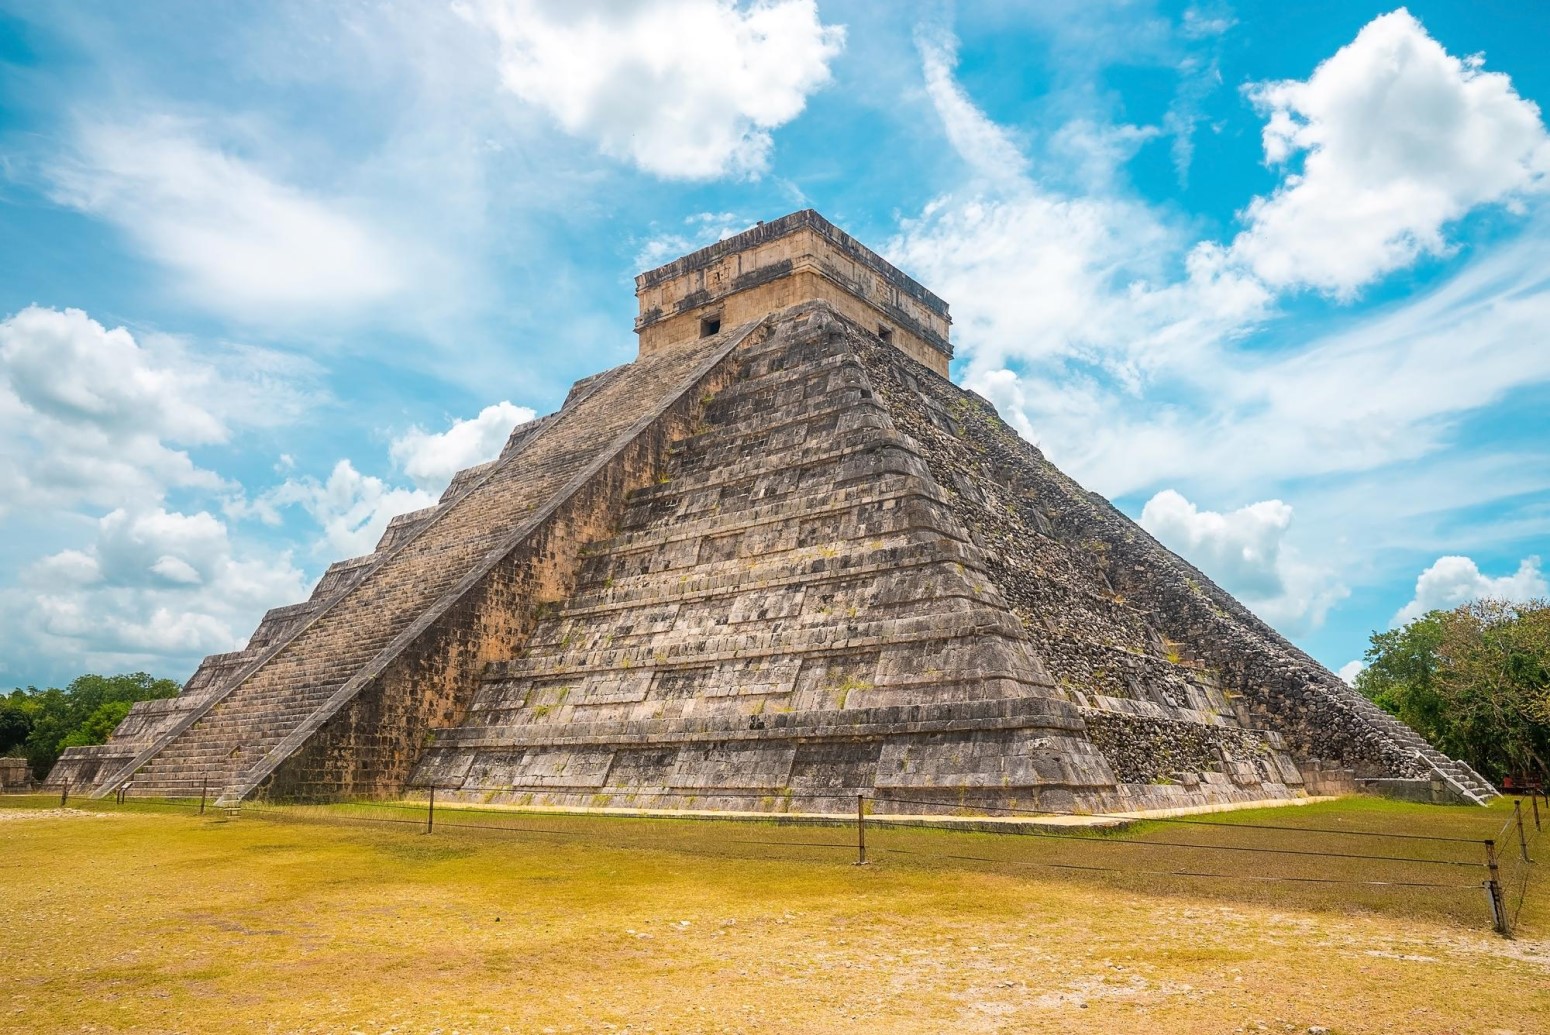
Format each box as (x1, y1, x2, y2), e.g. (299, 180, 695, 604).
(1232, 8, 1550, 297)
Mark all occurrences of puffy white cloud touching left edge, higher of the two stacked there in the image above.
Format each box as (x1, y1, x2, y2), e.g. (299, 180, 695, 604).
(0, 305, 310, 514)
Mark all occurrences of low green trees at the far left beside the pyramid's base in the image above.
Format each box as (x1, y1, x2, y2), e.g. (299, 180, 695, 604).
(0, 672, 180, 779)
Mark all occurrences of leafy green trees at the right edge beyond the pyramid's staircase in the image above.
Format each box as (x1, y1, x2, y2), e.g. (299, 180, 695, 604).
(1356, 600, 1550, 784)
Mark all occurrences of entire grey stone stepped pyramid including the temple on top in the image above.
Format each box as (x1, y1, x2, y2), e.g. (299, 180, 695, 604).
(51, 211, 1493, 812)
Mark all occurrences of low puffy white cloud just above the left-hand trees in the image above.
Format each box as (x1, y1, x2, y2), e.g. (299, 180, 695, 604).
(13, 507, 307, 671)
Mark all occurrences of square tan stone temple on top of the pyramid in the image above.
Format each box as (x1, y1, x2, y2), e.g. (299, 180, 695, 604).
(636, 209, 953, 377)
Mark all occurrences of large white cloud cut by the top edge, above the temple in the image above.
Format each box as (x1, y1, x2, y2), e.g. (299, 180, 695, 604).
(454, 0, 845, 180)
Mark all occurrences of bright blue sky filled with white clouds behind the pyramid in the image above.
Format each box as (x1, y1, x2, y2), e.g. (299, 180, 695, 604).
(0, 0, 1550, 686)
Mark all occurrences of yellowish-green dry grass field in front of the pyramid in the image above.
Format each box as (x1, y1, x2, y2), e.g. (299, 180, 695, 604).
(0, 798, 1550, 1035)
